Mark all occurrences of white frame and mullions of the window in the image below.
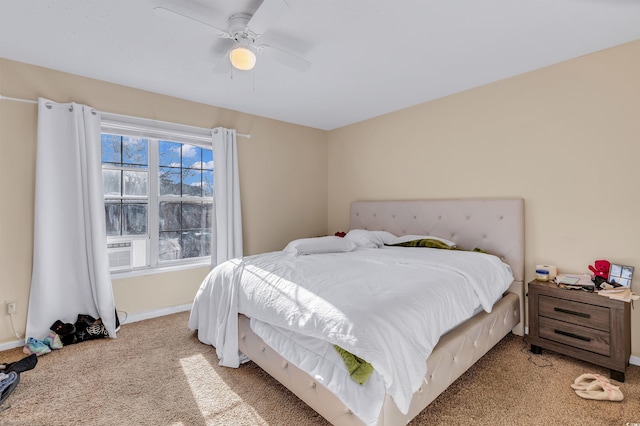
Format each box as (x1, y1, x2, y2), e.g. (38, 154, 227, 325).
(100, 113, 215, 278)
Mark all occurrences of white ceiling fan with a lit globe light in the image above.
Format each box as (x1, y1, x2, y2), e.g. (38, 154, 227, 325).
(154, 0, 311, 72)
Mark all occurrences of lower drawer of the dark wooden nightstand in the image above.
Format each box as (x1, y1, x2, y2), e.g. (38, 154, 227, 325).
(539, 317, 610, 356)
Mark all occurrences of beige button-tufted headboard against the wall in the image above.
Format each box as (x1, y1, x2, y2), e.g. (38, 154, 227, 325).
(350, 198, 524, 283)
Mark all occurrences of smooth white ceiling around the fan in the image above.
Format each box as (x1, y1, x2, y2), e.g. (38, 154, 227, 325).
(0, 0, 640, 130)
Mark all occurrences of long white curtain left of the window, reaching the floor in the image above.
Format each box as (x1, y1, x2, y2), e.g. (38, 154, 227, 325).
(26, 99, 116, 339)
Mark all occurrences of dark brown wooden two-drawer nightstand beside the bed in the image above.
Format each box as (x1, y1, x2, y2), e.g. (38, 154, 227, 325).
(528, 280, 631, 382)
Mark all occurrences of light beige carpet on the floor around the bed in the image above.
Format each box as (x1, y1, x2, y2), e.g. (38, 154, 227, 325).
(0, 312, 640, 426)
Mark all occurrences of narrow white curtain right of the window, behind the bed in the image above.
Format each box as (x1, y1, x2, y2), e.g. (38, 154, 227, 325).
(211, 127, 242, 268)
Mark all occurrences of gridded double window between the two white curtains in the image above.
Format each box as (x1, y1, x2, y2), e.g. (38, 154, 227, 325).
(101, 125, 213, 271)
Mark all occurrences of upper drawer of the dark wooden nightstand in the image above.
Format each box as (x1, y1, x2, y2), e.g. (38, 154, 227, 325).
(538, 290, 610, 332)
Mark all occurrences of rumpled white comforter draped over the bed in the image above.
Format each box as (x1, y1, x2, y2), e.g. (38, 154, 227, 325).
(189, 247, 513, 420)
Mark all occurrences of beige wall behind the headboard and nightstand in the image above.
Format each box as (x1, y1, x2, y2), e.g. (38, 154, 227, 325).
(329, 41, 640, 356)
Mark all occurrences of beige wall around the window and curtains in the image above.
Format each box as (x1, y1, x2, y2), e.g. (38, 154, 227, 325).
(0, 58, 327, 343)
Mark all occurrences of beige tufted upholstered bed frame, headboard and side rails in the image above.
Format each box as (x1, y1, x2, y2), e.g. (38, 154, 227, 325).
(238, 198, 524, 426)
